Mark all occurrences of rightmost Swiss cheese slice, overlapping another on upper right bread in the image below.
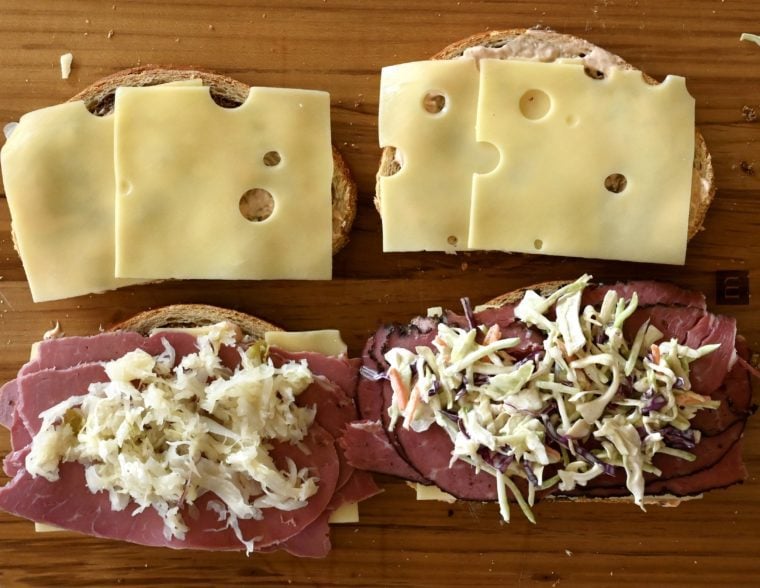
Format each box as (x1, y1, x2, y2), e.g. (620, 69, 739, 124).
(469, 60, 694, 264)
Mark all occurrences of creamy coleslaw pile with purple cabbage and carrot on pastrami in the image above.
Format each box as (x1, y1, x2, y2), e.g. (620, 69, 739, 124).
(385, 275, 719, 522)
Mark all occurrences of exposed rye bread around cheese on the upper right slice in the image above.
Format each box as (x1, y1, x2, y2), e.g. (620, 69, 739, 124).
(375, 29, 715, 239)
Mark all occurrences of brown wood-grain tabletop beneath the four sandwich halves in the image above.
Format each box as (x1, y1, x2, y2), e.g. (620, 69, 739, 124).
(0, 0, 760, 588)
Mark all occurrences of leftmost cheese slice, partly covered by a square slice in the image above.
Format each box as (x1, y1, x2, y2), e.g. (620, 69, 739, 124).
(0, 102, 144, 302)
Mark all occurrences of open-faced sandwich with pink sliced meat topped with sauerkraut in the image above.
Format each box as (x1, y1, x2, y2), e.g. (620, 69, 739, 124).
(0, 305, 379, 557)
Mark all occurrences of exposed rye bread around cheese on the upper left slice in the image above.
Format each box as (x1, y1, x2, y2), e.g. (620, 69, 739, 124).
(69, 65, 357, 255)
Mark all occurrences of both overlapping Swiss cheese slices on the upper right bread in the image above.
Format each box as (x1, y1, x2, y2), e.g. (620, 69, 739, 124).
(379, 59, 694, 264)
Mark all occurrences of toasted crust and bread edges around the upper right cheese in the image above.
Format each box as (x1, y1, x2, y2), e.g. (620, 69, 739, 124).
(375, 29, 715, 240)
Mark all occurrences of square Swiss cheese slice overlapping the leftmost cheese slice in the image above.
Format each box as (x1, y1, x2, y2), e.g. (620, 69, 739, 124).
(115, 86, 332, 279)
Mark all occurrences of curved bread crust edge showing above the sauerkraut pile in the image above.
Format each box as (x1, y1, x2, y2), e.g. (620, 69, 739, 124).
(109, 304, 282, 339)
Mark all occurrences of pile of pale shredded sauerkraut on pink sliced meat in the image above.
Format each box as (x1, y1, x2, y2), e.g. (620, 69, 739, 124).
(26, 323, 318, 552)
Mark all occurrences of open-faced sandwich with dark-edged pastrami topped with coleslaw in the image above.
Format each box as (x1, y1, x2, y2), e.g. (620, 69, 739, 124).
(342, 276, 753, 520)
